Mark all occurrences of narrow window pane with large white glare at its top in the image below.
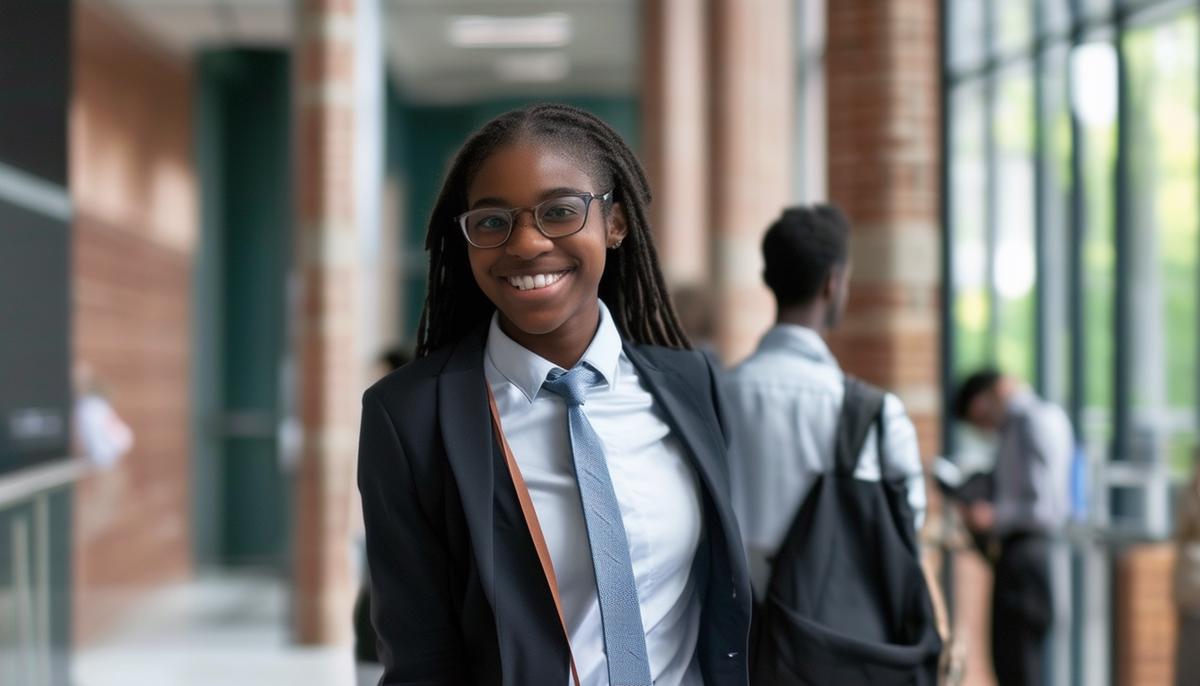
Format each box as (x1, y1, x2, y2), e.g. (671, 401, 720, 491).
(1070, 42, 1117, 459)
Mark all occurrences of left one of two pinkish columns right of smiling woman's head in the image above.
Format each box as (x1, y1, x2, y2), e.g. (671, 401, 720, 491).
(641, 0, 710, 284)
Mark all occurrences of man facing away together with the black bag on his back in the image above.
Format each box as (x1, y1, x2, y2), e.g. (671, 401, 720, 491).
(724, 205, 941, 686)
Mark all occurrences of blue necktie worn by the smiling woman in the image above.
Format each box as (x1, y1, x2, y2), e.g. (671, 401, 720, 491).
(542, 365, 652, 686)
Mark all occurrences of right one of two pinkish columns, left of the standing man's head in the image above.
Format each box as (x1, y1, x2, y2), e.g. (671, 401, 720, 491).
(709, 0, 796, 362)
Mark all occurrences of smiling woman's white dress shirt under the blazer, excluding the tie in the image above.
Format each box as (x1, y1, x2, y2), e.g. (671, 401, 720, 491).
(484, 302, 703, 686)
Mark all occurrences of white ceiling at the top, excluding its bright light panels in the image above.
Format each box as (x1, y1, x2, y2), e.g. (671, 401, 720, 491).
(94, 0, 640, 103)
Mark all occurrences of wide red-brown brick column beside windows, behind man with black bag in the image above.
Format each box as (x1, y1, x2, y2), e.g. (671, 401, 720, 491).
(826, 0, 941, 457)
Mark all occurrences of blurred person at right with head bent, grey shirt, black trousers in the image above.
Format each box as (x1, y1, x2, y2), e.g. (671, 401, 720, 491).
(954, 369, 1075, 686)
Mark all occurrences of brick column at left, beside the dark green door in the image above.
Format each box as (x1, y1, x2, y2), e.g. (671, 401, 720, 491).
(293, 0, 362, 644)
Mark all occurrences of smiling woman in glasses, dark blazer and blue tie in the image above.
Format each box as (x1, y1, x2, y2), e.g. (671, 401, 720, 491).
(359, 104, 750, 686)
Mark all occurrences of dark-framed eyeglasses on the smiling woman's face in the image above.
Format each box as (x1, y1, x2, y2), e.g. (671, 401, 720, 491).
(455, 191, 612, 248)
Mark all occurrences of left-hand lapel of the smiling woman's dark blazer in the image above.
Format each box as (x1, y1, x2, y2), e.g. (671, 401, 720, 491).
(438, 327, 496, 607)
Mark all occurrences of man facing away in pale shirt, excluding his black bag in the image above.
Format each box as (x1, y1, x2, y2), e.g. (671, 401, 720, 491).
(724, 205, 925, 600)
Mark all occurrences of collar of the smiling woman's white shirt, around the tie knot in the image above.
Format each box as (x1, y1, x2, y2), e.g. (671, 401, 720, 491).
(486, 300, 623, 403)
